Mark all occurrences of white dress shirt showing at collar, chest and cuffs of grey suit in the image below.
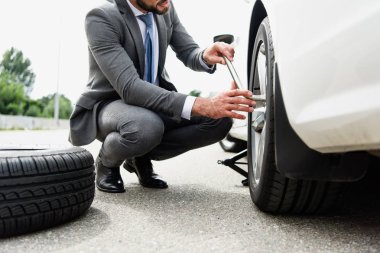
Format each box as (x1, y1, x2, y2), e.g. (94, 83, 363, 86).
(126, 0, 212, 119)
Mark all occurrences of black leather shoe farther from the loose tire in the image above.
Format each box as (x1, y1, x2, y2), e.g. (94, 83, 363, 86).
(123, 157, 168, 189)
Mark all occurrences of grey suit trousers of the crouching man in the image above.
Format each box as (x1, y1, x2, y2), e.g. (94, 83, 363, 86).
(97, 100, 232, 167)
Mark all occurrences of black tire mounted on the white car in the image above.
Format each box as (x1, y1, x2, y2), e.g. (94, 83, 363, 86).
(248, 18, 343, 214)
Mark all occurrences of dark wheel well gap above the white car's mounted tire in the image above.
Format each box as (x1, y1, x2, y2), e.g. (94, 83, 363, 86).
(247, 0, 267, 80)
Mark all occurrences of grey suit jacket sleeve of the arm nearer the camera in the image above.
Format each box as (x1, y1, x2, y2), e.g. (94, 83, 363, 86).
(85, 8, 186, 120)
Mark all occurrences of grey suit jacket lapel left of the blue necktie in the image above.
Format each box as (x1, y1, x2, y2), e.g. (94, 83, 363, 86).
(115, 0, 145, 78)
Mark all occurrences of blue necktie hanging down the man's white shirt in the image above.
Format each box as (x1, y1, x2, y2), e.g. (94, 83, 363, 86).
(138, 13, 155, 83)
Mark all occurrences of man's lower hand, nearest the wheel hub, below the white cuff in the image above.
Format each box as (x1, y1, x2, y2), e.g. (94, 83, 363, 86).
(192, 90, 256, 119)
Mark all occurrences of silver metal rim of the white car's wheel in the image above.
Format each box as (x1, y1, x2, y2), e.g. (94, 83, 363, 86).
(251, 42, 267, 185)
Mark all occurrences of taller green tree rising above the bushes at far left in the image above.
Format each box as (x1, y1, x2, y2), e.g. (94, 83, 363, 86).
(0, 47, 36, 95)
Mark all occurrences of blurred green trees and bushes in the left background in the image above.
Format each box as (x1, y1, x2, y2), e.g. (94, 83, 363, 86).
(0, 47, 73, 119)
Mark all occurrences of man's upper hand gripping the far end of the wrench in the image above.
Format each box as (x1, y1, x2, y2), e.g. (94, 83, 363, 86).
(202, 42, 235, 65)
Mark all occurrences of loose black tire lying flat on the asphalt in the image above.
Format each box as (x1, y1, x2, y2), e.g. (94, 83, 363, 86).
(0, 147, 95, 237)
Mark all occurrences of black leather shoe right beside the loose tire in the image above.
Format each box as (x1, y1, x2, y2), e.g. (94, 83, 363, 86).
(95, 157, 125, 193)
